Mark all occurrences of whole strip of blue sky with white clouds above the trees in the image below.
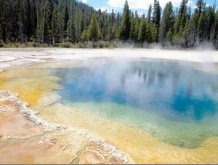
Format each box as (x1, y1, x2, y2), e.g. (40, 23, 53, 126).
(80, 0, 218, 12)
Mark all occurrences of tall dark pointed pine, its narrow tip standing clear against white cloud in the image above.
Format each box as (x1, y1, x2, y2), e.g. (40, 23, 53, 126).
(120, 0, 131, 40)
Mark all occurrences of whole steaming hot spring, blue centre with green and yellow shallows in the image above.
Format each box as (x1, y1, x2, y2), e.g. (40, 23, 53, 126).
(0, 58, 218, 163)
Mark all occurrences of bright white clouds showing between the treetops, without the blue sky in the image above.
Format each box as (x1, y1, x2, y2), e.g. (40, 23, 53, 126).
(108, 0, 193, 10)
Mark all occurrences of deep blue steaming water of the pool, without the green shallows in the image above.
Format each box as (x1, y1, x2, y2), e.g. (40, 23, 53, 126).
(57, 60, 218, 122)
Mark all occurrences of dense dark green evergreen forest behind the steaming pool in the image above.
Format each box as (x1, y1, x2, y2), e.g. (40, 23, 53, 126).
(0, 0, 218, 48)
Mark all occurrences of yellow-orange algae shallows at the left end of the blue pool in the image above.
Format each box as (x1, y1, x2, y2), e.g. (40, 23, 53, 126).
(0, 67, 58, 107)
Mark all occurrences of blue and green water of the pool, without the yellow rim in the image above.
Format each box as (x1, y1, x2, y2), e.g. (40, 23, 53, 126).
(55, 60, 218, 148)
